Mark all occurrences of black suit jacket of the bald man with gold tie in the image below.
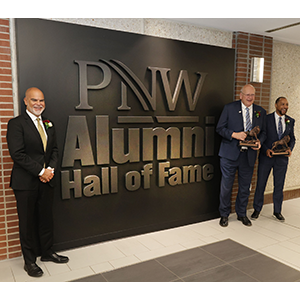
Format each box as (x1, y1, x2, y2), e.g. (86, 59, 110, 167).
(6, 112, 58, 190)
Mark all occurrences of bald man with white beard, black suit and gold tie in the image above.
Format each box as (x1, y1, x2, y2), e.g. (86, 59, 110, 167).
(6, 88, 69, 277)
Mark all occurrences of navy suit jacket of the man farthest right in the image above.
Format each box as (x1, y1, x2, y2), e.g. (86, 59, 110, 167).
(259, 112, 296, 164)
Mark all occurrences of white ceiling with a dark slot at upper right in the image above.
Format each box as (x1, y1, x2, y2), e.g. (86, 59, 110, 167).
(168, 18, 300, 45)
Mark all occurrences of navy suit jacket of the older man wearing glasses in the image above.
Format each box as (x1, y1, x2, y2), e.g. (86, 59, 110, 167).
(216, 100, 266, 166)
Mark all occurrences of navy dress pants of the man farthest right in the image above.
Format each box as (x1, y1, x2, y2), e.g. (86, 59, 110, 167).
(253, 157, 288, 213)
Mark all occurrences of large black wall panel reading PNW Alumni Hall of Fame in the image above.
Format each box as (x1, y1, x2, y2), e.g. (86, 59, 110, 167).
(16, 19, 235, 250)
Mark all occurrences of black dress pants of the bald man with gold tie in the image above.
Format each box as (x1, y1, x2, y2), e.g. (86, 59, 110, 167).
(14, 182, 53, 264)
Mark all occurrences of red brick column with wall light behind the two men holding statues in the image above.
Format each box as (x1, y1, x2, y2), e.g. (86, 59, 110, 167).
(231, 32, 273, 212)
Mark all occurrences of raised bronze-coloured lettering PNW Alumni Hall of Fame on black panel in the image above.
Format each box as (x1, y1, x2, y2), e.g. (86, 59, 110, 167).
(61, 59, 215, 199)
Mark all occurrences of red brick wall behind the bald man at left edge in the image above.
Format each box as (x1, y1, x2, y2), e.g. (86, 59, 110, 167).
(0, 19, 21, 260)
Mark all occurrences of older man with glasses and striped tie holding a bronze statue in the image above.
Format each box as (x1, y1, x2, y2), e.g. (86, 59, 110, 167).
(216, 84, 266, 227)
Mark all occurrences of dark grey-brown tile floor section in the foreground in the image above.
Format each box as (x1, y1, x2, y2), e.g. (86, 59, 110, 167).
(74, 239, 300, 282)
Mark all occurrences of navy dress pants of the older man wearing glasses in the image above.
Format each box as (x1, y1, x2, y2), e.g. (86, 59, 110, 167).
(219, 152, 254, 217)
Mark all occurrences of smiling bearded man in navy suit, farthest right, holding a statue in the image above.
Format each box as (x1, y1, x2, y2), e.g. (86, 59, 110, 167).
(251, 97, 296, 221)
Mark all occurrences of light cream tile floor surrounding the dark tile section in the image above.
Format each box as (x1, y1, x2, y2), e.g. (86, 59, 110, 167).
(0, 198, 300, 282)
